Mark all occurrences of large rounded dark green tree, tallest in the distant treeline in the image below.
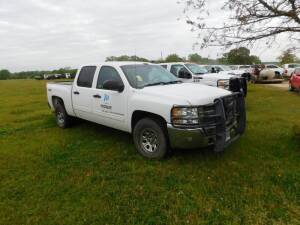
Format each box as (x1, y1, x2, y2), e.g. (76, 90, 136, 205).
(220, 47, 261, 65)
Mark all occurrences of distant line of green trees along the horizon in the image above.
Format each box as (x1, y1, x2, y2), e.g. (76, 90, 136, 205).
(0, 47, 300, 80)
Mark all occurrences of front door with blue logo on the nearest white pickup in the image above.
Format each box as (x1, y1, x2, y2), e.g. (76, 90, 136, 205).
(93, 65, 127, 129)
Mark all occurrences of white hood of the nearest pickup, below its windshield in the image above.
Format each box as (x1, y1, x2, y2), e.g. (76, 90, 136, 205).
(140, 83, 231, 105)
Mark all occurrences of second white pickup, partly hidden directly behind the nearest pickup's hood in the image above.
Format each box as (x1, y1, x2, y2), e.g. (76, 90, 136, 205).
(160, 62, 247, 96)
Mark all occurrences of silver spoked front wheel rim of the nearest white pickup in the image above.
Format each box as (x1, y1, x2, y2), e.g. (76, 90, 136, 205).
(140, 128, 158, 153)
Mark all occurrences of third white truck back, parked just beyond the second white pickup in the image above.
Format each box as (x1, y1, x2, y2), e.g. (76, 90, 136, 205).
(204, 65, 251, 81)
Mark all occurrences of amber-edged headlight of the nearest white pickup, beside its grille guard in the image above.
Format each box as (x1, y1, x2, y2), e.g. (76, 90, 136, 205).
(171, 107, 199, 127)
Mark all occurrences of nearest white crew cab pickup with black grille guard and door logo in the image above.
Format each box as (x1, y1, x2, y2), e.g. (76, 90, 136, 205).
(47, 62, 246, 159)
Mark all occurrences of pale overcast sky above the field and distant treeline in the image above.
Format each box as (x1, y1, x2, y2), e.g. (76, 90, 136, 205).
(0, 0, 296, 71)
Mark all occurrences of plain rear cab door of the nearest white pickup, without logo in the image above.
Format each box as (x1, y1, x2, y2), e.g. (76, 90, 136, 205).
(72, 66, 97, 120)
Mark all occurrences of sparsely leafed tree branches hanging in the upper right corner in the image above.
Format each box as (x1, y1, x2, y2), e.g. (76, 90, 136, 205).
(182, 0, 300, 48)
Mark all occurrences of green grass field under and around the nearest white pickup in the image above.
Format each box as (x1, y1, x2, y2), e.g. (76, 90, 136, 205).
(0, 80, 300, 225)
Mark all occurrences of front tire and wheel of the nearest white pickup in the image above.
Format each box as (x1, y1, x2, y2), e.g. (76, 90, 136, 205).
(133, 118, 168, 159)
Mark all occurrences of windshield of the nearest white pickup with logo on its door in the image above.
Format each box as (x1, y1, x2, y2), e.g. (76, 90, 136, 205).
(121, 64, 180, 88)
